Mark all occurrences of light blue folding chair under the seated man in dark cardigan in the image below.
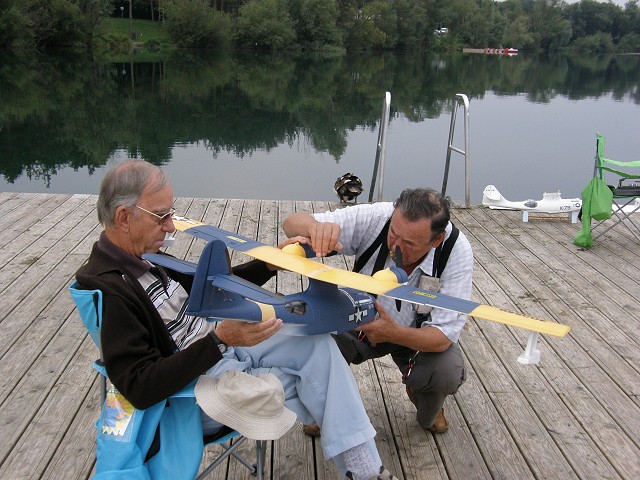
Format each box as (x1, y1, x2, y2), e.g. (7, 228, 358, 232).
(69, 282, 266, 480)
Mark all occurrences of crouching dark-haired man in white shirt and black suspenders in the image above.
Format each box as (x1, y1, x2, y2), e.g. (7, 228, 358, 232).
(284, 188, 473, 436)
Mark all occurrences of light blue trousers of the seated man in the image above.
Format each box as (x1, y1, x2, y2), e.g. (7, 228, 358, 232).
(205, 334, 380, 474)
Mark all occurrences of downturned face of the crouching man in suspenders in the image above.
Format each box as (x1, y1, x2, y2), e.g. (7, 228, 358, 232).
(387, 210, 444, 266)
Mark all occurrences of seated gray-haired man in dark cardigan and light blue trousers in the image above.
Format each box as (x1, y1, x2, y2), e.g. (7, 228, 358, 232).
(76, 160, 396, 480)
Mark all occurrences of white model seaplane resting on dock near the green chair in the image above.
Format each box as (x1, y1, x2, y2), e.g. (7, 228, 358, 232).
(482, 185, 582, 223)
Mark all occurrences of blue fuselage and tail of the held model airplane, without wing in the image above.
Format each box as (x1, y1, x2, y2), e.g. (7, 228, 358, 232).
(143, 239, 406, 335)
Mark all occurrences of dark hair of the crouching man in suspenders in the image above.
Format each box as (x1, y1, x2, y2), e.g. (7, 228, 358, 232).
(393, 188, 451, 237)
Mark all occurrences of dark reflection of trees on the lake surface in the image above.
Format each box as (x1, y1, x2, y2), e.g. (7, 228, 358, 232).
(0, 52, 640, 199)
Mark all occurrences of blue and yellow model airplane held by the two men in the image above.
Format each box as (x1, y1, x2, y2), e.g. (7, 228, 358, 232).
(144, 217, 570, 337)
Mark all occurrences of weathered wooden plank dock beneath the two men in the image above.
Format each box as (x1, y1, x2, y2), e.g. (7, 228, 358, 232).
(0, 192, 640, 480)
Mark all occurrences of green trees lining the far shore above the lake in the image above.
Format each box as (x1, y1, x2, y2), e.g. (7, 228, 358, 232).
(0, 0, 640, 53)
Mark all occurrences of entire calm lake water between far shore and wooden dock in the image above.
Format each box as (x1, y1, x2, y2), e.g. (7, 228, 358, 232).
(0, 52, 640, 203)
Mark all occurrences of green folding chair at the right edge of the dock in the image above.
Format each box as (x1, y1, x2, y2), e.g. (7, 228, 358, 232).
(591, 133, 640, 240)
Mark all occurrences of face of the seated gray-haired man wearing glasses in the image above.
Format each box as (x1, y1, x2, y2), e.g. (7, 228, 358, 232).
(129, 186, 175, 257)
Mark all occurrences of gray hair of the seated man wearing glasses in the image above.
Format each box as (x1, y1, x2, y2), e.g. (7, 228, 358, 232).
(96, 160, 170, 227)
